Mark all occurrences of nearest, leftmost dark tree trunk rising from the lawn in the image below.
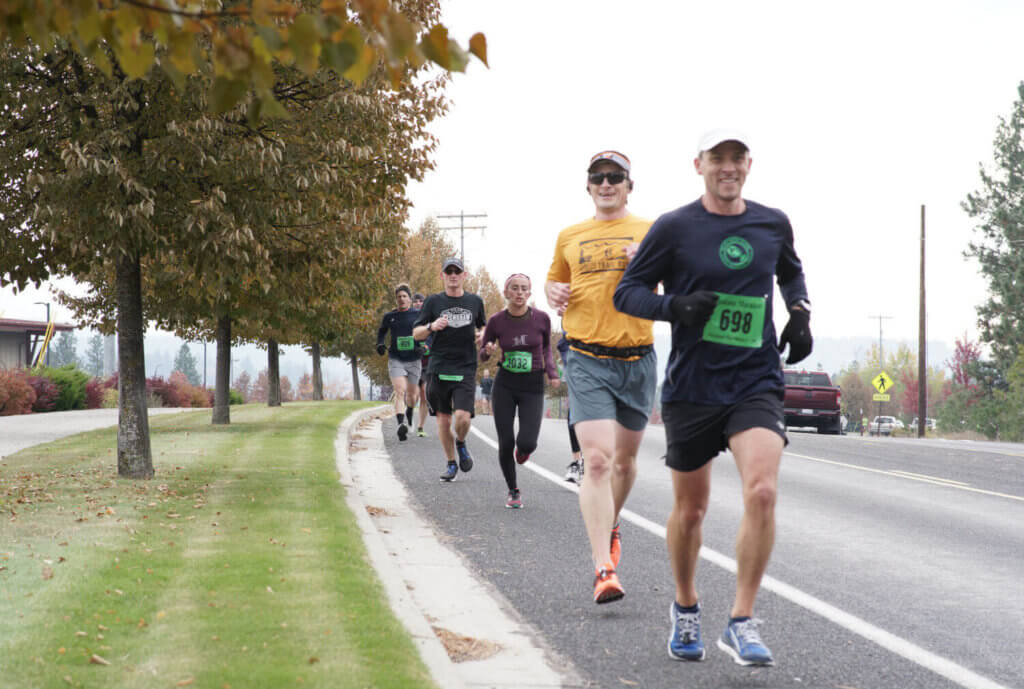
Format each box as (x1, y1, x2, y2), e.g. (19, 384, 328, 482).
(116, 254, 156, 478)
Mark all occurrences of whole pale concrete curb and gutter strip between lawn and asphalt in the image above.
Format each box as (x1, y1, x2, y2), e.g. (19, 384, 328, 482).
(335, 406, 582, 689)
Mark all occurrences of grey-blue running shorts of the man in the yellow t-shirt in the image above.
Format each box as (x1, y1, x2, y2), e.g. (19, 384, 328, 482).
(565, 349, 657, 431)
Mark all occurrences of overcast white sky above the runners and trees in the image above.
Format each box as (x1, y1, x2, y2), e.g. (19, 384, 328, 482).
(0, 0, 1024, 352)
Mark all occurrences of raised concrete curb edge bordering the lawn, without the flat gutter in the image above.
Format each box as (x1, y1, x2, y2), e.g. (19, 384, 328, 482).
(334, 405, 468, 689)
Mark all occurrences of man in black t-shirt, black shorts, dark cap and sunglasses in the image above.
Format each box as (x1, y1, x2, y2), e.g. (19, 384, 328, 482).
(413, 258, 486, 481)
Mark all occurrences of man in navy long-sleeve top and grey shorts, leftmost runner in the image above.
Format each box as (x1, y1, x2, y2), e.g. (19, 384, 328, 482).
(377, 284, 421, 440)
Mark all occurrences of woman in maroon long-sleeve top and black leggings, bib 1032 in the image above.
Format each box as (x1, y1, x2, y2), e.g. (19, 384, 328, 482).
(480, 272, 558, 509)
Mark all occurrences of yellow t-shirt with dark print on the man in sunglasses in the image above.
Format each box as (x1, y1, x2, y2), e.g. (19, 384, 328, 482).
(548, 214, 654, 347)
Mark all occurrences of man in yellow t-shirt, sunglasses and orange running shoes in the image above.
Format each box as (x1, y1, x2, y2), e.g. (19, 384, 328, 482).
(545, 150, 657, 603)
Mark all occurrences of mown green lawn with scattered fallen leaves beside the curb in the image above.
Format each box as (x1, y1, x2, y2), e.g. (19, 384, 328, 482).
(0, 402, 436, 689)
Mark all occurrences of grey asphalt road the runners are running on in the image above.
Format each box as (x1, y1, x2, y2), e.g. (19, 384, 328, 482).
(384, 417, 1024, 689)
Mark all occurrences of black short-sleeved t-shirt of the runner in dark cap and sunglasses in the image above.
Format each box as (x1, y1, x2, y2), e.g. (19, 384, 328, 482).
(415, 292, 487, 376)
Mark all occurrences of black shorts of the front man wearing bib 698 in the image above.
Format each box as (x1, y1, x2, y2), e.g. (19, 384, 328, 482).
(662, 392, 790, 471)
